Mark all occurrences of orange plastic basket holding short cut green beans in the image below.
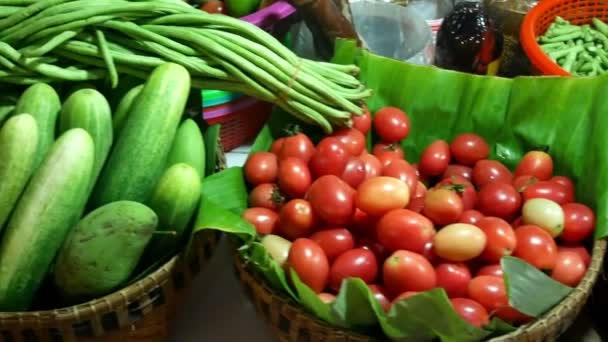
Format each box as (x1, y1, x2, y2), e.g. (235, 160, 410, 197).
(520, 0, 608, 76)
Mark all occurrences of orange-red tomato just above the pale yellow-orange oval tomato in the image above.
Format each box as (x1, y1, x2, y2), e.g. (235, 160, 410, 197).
(422, 188, 464, 226)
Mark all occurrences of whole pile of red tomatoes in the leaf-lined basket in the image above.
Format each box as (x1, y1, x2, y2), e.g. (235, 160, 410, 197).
(243, 107, 595, 327)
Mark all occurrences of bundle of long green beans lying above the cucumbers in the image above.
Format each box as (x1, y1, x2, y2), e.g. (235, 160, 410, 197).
(0, 0, 371, 132)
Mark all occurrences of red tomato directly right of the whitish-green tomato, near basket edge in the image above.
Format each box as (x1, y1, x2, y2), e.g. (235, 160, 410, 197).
(559, 203, 595, 243)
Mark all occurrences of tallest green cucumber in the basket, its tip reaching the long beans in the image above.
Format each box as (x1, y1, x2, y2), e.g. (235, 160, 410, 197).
(93, 63, 190, 207)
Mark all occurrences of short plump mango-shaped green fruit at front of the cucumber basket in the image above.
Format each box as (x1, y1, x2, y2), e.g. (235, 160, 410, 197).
(54, 201, 158, 302)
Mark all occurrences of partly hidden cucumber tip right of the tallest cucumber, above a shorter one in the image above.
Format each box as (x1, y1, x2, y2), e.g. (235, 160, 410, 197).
(167, 119, 205, 179)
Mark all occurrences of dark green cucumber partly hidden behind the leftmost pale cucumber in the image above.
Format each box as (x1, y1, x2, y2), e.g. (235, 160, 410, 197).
(13, 83, 61, 169)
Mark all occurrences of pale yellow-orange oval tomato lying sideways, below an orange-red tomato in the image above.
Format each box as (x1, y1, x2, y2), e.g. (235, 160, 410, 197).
(433, 223, 487, 262)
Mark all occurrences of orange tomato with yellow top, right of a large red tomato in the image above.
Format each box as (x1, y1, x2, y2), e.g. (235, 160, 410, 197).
(354, 176, 410, 216)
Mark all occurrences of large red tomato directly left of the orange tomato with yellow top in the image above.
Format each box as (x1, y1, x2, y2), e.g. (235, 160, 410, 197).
(308, 175, 355, 226)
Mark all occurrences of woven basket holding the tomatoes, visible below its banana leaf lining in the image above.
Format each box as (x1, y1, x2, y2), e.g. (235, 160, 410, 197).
(234, 240, 606, 342)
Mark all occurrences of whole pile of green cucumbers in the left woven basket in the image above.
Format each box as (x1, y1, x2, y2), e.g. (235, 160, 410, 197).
(0, 63, 205, 311)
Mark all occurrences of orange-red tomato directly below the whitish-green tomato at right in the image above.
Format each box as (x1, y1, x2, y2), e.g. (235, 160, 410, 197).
(513, 225, 557, 270)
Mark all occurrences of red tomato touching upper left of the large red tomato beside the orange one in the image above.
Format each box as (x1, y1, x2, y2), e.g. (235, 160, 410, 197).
(278, 157, 311, 198)
